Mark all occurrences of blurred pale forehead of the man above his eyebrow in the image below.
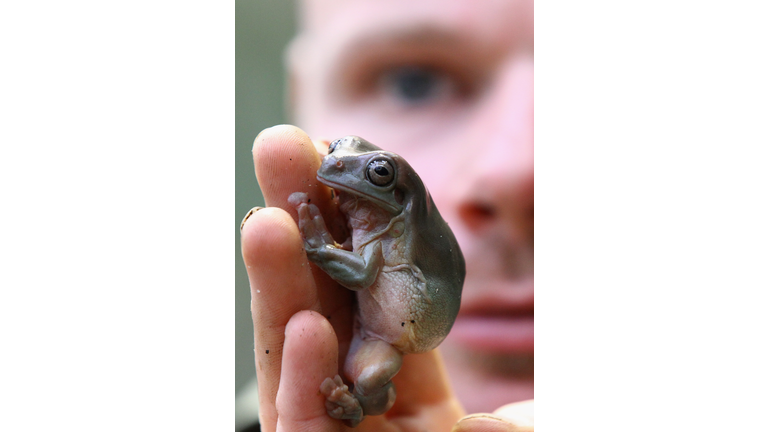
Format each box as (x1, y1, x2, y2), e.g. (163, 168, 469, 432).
(300, 0, 533, 47)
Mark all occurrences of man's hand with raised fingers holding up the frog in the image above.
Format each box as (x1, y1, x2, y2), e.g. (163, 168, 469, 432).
(241, 126, 532, 432)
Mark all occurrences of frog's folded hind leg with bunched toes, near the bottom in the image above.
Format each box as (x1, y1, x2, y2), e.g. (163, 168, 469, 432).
(320, 332, 403, 427)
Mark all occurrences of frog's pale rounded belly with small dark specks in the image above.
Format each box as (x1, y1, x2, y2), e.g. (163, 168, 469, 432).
(357, 269, 451, 353)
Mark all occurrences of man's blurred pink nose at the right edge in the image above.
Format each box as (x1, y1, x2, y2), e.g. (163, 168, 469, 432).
(456, 57, 534, 246)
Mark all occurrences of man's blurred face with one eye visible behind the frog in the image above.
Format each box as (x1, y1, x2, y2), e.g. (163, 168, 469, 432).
(289, 0, 534, 412)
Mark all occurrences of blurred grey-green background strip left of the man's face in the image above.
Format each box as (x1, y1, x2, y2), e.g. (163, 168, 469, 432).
(233, 0, 296, 392)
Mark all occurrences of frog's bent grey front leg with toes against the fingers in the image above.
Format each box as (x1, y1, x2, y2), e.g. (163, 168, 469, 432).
(288, 192, 384, 291)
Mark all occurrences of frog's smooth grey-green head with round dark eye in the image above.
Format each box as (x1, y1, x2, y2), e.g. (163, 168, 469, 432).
(317, 135, 424, 215)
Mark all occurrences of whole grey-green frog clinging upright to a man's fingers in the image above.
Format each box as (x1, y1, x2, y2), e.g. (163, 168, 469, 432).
(289, 136, 465, 426)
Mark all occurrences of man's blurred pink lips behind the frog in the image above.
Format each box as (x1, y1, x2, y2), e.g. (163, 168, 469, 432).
(448, 281, 534, 354)
